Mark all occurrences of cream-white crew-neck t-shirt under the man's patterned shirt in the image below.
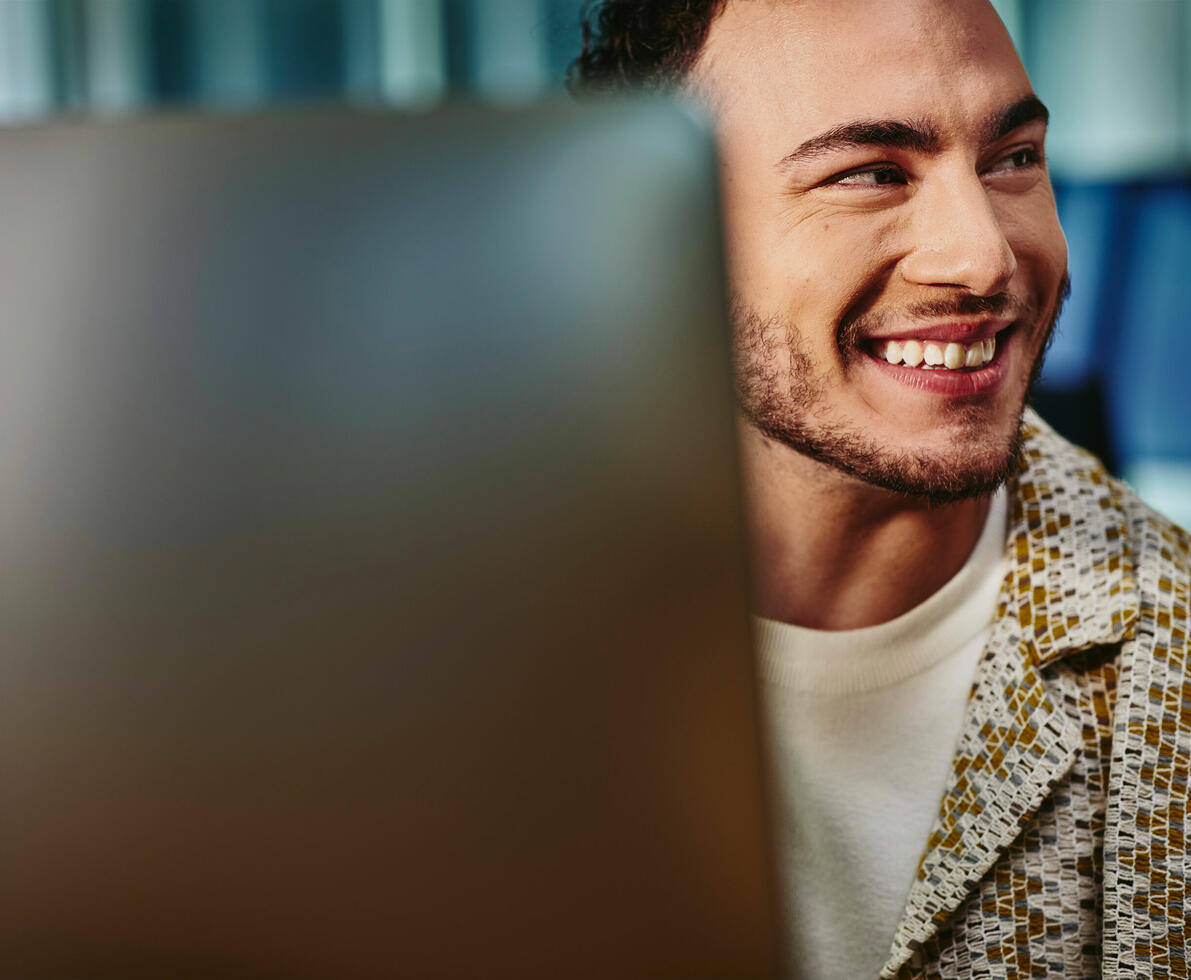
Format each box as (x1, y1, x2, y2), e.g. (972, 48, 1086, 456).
(756, 489, 1009, 980)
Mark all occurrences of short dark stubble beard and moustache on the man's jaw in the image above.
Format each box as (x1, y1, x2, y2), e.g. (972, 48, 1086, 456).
(732, 275, 1070, 505)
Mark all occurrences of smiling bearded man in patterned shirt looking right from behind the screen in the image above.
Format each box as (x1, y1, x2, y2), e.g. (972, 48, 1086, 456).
(573, 0, 1191, 980)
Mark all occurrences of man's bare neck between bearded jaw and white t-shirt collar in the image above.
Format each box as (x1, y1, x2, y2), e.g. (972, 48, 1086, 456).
(741, 424, 989, 630)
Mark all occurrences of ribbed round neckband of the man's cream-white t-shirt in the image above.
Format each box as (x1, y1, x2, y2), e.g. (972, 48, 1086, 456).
(754, 487, 1009, 695)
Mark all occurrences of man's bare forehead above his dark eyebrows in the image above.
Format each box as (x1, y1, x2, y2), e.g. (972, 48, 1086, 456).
(691, 0, 1031, 142)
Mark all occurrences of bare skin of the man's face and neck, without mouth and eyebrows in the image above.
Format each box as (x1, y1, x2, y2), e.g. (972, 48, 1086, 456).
(691, 0, 1067, 629)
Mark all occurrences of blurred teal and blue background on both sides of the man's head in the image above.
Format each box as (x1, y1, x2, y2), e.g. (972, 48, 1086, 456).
(0, 0, 1191, 525)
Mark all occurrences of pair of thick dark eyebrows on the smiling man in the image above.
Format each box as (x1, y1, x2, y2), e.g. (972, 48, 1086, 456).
(778, 95, 1050, 171)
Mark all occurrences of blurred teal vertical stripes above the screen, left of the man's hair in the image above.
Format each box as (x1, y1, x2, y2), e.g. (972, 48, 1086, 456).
(0, 0, 580, 120)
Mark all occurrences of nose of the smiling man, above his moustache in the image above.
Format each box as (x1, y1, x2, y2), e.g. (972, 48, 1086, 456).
(902, 174, 1017, 297)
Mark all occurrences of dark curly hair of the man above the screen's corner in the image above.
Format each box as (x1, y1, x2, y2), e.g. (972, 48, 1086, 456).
(567, 0, 727, 95)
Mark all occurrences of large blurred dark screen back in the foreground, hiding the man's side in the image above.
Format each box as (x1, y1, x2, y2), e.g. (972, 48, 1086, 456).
(0, 105, 775, 980)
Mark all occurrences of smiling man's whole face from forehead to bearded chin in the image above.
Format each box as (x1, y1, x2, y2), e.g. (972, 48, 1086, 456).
(692, 0, 1067, 500)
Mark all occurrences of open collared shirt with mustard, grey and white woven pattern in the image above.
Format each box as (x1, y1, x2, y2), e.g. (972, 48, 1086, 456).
(881, 411, 1191, 980)
